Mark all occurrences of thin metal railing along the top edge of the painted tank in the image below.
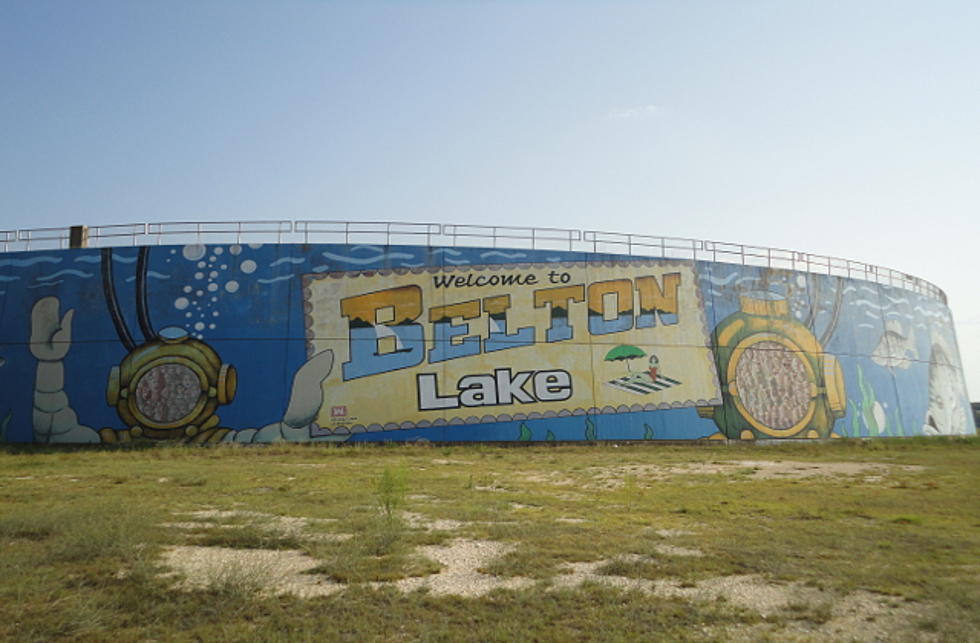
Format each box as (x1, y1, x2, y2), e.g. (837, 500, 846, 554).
(0, 220, 946, 303)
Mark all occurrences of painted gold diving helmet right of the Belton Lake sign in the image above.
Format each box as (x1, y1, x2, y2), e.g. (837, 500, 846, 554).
(698, 291, 846, 440)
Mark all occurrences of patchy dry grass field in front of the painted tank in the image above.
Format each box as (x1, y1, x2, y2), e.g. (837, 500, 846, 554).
(0, 438, 980, 641)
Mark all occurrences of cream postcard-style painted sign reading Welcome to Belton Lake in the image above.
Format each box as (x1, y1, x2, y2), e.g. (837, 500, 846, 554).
(303, 260, 721, 432)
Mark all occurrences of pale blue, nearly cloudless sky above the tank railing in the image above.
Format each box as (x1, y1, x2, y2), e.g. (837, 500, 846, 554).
(0, 0, 980, 399)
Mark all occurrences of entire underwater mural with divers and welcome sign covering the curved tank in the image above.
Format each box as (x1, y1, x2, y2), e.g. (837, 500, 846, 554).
(0, 244, 975, 443)
